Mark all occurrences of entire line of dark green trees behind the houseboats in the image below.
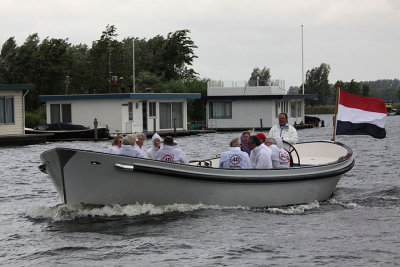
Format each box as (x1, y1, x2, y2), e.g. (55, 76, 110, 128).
(0, 25, 400, 121)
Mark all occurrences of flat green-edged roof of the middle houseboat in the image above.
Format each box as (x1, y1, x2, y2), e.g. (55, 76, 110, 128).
(39, 93, 201, 101)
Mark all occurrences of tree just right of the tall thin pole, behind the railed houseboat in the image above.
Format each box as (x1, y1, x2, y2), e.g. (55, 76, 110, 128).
(304, 63, 334, 105)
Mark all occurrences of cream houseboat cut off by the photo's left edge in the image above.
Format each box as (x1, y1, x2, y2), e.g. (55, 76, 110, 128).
(0, 84, 34, 136)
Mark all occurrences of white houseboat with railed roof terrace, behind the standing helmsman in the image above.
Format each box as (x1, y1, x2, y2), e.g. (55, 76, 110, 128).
(205, 80, 316, 130)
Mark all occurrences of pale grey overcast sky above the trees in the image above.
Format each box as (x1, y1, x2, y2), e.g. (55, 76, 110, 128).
(0, 0, 400, 89)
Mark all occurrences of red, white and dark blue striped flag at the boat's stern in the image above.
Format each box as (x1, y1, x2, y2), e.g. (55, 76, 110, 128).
(336, 89, 387, 138)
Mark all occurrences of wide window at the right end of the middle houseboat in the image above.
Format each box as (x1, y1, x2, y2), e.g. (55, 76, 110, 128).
(160, 102, 183, 129)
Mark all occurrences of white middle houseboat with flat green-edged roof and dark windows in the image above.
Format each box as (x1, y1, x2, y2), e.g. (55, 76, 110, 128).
(39, 93, 201, 134)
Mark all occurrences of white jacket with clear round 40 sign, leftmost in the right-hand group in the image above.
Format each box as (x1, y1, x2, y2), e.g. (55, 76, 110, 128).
(219, 147, 251, 169)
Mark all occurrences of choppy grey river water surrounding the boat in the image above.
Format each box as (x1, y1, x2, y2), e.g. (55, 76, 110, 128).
(0, 115, 400, 266)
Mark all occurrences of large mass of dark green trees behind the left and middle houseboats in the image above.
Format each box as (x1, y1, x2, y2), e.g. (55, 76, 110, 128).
(0, 25, 197, 111)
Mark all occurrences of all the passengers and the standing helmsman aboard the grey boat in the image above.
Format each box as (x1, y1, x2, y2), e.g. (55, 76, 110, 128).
(107, 113, 298, 169)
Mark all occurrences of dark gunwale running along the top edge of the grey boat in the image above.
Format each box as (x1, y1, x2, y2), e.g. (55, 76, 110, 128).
(41, 141, 355, 183)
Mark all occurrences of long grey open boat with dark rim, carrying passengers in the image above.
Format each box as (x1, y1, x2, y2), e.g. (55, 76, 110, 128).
(40, 141, 354, 207)
